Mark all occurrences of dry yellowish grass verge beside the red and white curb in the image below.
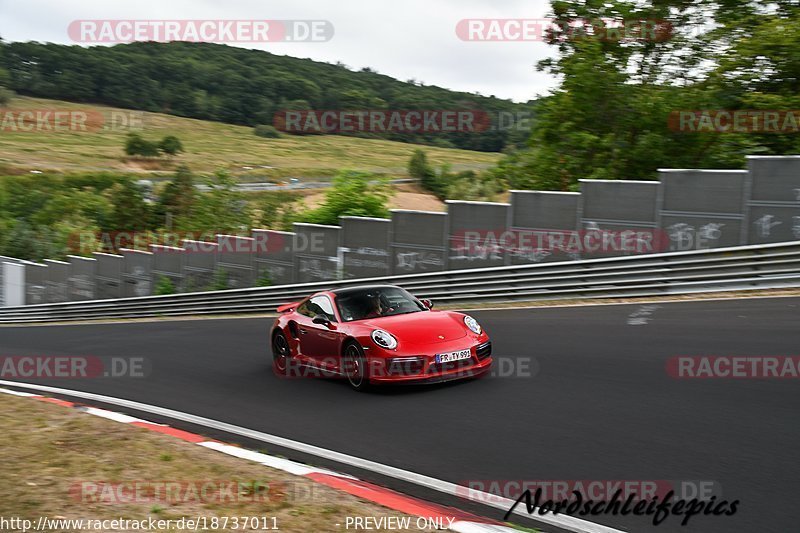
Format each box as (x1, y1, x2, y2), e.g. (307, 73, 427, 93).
(0, 394, 438, 533)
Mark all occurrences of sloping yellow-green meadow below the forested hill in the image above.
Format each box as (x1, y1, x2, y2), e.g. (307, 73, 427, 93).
(0, 97, 500, 181)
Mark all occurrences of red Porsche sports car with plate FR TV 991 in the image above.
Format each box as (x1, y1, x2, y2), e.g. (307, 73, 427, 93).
(271, 285, 492, 390)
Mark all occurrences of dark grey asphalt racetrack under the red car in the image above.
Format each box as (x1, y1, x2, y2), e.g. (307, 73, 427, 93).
(0, 298, 800, 533)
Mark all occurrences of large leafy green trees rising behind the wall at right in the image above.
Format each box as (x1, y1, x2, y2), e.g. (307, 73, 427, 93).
(492, 0, 800, 191)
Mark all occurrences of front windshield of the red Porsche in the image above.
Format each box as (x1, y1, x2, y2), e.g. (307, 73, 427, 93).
(336, 287, 428, 322)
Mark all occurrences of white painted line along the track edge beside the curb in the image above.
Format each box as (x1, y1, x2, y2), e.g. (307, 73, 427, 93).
(0, 380, 624, 533)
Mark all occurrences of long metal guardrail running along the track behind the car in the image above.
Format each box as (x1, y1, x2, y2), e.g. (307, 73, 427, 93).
(0, 241, 800, 324)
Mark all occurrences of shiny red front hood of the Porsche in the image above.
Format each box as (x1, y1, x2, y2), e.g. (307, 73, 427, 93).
(362, 311, 467, 344)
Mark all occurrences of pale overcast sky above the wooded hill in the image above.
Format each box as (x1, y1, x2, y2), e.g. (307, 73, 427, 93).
(0, 0, 555, 101)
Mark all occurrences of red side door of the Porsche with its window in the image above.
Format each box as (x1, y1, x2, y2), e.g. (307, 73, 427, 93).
(297, 295, 339, 369)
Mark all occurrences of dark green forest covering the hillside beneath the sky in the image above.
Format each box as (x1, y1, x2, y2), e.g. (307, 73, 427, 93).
(0, 41, 531, 152)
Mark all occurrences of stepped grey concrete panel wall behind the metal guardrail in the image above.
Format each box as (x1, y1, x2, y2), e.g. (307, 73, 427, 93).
(0, 156, 800, 305)
